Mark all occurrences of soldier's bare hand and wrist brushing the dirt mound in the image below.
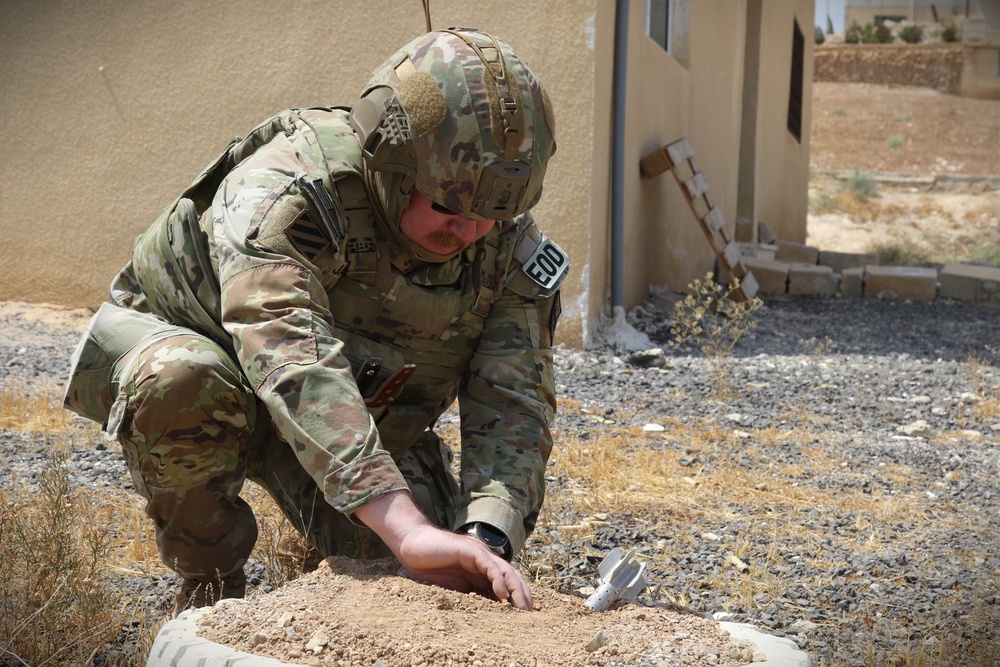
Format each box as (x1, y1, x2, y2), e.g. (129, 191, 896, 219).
(355, 491, 534, 611)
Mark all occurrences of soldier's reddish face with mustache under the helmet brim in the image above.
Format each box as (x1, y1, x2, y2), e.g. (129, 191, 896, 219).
(399, 194, 495, 255)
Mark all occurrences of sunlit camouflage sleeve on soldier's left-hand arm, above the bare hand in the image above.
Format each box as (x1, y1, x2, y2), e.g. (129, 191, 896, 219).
(212, 137, 407, 515)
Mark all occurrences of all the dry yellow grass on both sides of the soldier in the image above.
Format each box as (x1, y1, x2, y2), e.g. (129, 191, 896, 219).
(0, 360, 1000, 667)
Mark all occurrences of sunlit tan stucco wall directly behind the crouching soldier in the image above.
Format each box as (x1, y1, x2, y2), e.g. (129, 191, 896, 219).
(0, 0, 596, 348)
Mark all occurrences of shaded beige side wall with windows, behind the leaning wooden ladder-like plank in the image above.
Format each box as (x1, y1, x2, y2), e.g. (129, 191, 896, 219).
(597, 0, 814, 309)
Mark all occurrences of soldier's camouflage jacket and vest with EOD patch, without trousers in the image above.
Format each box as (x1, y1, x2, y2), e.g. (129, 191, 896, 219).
(111, 109, 568, 552)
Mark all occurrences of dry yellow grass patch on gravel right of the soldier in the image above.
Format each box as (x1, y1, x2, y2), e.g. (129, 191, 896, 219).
(525, 420, 1000, 667)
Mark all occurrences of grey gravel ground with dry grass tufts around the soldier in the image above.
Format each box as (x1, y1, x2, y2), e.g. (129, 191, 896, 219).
(0, 297, 1000, 665)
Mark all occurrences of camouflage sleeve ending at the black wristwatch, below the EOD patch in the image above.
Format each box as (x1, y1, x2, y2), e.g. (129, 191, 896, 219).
(456, 219, 568, 553)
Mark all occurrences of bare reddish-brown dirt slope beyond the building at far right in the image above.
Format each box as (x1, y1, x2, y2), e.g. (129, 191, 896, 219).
(806, 83, 1000, 263)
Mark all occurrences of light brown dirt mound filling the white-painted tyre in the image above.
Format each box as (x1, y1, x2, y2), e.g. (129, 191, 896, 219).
(199, 558, 754, 667)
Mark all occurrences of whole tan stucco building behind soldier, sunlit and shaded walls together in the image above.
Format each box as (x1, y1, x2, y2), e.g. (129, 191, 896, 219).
(0, 0, 814, 344)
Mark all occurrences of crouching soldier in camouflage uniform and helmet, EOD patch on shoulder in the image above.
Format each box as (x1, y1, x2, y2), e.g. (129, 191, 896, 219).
(65, 28, 569, 613)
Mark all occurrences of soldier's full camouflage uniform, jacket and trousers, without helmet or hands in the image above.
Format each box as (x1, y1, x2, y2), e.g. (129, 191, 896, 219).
(66, 100, 568, 602)
